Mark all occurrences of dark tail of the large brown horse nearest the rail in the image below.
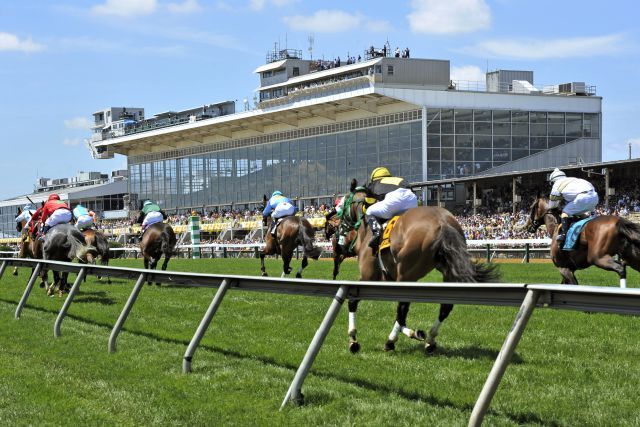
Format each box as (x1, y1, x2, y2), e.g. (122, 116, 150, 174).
(434, 224, 500, 283)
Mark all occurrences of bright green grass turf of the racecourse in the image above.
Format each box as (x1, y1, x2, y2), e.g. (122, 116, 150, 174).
(0, 259, 640, 426)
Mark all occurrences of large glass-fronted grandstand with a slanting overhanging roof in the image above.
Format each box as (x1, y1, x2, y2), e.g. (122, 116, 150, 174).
(84, 48, 602, 210)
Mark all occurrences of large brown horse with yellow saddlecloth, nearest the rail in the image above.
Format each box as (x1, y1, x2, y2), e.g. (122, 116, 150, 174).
(343, 180, 499, 354)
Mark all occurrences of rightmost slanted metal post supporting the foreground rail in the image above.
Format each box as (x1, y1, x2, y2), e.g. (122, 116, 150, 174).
(469, 290, 540, 427)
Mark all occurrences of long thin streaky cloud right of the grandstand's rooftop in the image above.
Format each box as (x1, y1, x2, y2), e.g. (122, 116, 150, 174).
(464, 34, 624, 59)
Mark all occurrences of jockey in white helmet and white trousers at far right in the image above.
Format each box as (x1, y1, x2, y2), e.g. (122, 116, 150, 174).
(549, 168, 598, 242)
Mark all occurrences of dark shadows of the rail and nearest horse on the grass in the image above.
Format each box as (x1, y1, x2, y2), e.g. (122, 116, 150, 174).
(0, 298, 559, 426)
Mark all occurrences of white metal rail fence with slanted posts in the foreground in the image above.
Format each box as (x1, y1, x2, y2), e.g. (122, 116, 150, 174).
(0, 258, 640, 426)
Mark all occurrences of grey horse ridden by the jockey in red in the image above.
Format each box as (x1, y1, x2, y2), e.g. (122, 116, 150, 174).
(42, 224, 97, 296)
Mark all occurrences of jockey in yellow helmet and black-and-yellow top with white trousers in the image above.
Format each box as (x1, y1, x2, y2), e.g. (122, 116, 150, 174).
(365, 167, 418, 252)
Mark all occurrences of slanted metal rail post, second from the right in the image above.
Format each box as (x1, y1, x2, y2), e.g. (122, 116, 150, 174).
(280, 285, 349, 410)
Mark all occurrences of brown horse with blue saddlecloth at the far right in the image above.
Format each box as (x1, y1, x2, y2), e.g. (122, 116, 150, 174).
(525, 197, 640, 287)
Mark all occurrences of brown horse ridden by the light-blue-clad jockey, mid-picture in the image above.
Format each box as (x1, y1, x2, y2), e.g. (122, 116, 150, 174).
(260, 196, 322, 278)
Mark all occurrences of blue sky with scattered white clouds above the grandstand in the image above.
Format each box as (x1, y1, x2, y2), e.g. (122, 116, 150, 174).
(0, 0, 640, 199)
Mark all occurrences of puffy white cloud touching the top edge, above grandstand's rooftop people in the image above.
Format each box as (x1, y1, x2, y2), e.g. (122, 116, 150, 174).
(407, 0, 491, 34)
